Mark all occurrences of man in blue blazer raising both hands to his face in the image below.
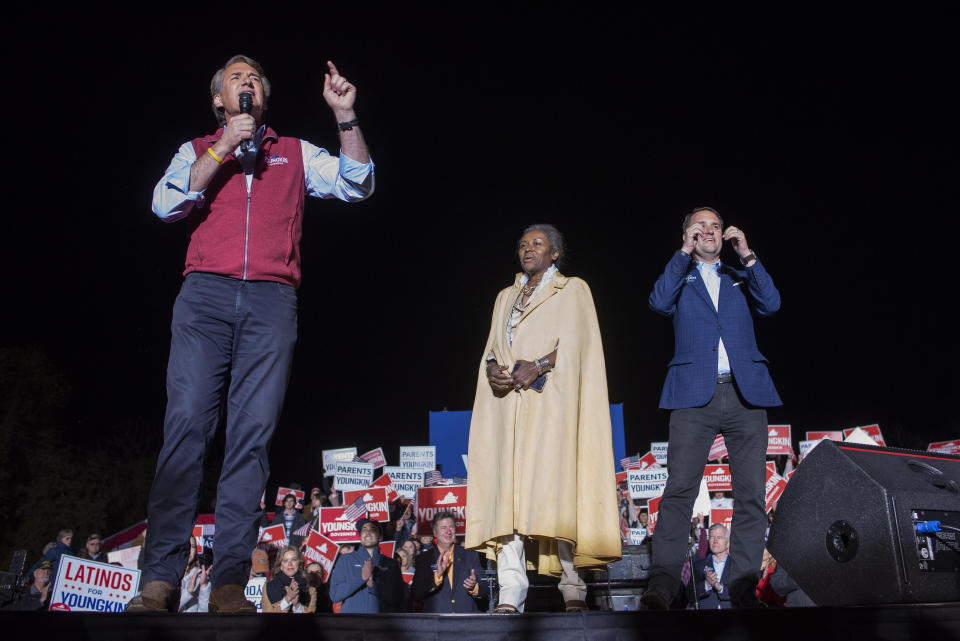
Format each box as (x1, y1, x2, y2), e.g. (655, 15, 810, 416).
(642, 207, 782, 609)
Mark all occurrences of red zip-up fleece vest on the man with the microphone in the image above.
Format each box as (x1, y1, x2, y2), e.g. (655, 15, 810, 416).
(183, 127, 306, 287)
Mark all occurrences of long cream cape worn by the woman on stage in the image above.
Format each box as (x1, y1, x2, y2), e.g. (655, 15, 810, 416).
(465, 274, 621, 576)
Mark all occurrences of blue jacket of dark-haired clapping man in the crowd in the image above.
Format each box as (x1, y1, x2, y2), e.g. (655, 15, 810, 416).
(330, 547, 405, 614)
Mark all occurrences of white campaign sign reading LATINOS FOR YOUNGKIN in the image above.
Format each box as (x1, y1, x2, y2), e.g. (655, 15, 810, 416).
(50, 554, 140, 612)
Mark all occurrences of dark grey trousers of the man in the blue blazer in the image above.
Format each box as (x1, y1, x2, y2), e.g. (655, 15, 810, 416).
(650, 383, 767, 601)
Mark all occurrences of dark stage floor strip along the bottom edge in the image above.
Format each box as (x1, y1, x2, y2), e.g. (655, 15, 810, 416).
(0, 603, 960, 641)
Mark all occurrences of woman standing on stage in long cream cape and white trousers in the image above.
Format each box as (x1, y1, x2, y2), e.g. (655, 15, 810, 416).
(465, 225, 621, 614)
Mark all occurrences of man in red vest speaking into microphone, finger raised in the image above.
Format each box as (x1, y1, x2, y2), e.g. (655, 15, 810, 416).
(127, 55, 374, 613)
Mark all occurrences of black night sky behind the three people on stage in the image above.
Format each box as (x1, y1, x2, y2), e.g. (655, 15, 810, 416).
(0, 3, 960, 504)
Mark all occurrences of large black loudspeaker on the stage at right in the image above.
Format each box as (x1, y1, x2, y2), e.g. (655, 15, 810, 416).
(764, 441, 960, 605)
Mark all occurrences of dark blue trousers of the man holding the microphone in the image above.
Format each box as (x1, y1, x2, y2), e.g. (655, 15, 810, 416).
(143, 273, 297, 588)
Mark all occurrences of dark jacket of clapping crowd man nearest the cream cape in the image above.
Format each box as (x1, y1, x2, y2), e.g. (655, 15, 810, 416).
(410, 544, 489, 614)
